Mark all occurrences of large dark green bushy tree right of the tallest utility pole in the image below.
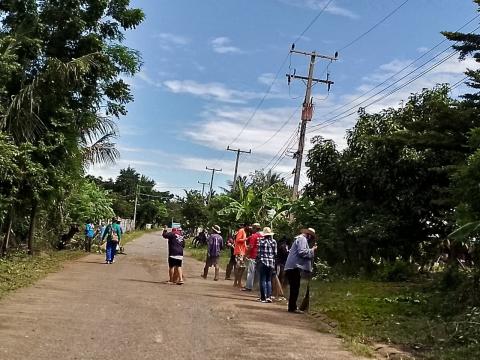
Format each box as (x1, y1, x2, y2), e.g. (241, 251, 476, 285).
(304, 86, 479, 271)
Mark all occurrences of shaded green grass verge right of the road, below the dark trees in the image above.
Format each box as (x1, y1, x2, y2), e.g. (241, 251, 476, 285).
(311, 279, 480, 359)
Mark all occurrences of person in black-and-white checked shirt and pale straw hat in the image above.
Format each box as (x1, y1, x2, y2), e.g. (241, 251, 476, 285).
(258, 227, 277, 303)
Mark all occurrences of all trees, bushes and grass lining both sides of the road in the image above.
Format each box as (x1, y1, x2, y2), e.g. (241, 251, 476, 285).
(0, 0, 480, 359)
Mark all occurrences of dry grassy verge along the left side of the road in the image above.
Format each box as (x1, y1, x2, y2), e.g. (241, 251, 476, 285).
(0, 250, 85, 299)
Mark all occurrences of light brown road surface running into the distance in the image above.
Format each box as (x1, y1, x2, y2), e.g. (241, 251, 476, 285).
(0, 233, 366, 360)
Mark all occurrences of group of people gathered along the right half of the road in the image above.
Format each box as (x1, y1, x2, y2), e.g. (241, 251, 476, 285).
(163, 223, 317, 313)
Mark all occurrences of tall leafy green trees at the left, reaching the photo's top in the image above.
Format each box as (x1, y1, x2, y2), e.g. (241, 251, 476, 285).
(0, 0, 144, 250)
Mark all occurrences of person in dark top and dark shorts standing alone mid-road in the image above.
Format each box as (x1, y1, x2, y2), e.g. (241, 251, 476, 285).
(162, 226, 185, 285)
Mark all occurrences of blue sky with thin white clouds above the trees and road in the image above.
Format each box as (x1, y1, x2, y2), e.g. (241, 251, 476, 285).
(89, 0, 479, 194)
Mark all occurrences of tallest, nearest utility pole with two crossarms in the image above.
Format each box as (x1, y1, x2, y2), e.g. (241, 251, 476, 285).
(287, 45, 338, 199)
